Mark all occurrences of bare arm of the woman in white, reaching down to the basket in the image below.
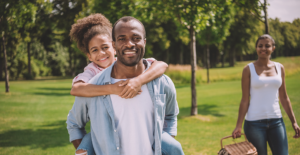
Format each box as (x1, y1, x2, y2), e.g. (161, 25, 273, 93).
(232, 66, 250, 138)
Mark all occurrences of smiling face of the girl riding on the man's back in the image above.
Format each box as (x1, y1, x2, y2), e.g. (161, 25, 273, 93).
(87, 35, 116, 68)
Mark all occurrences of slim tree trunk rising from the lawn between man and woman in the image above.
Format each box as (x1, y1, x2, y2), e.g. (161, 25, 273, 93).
(190, 26, 198, 115)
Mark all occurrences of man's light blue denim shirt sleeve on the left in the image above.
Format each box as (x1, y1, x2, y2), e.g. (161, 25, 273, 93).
(66, 97, 90, 142)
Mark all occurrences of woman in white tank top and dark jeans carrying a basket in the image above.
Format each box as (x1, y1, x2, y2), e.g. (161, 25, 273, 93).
(232, 34, 300, 155)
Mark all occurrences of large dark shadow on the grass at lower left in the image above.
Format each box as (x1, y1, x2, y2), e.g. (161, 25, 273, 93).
(0, 120, 70, 149)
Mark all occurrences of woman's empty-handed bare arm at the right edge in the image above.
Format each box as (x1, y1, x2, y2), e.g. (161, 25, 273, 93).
(279, 65, 300, 138)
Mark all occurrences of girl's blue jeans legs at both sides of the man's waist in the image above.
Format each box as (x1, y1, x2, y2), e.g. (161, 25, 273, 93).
(77, 132, 184, 155)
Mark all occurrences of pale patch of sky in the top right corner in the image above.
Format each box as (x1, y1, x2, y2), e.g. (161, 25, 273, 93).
(268, 0, 300, 22)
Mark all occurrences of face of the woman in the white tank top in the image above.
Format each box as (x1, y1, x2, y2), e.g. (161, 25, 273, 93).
(256, 39, 275, 58)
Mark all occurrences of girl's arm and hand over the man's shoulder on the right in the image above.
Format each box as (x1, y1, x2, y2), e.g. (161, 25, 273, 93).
(119, 59, 168, 98)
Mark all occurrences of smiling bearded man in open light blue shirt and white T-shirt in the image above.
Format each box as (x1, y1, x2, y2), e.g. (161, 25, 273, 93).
(67, 17, 183, 155)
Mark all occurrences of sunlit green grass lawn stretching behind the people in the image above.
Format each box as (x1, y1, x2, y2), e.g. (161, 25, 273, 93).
(0, 60, 300, 155)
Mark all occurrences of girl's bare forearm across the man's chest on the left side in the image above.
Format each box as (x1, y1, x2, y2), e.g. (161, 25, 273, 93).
(70, 81, 124, 97)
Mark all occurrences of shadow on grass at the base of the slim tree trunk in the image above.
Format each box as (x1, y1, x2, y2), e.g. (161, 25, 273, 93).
(178, 104, 224, 119)
